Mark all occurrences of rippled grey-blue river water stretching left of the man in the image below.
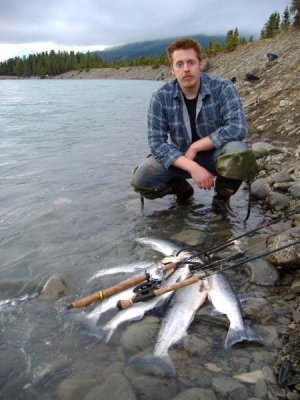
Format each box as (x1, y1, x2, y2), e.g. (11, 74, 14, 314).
(0, 80, 272, 399)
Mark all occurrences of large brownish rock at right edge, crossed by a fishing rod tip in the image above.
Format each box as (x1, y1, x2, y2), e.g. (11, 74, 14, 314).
(267, 227, 300, 266)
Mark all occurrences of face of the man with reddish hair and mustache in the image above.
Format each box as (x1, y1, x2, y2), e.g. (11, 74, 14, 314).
(171, 49, 203, 91)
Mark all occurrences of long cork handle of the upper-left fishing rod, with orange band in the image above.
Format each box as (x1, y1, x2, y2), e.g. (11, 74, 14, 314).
(67, 263, 176, 310)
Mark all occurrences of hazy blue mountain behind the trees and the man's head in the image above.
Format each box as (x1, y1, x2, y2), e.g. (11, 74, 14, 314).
(91, 35, 226, 61)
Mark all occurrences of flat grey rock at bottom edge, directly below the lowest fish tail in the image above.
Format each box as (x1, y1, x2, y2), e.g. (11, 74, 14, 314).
(132, 376, 177, 400)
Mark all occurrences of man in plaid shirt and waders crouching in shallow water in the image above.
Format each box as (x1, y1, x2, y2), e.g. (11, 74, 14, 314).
(132, 38, 255, 213)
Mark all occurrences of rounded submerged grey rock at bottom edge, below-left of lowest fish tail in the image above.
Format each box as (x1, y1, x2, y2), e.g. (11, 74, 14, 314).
(82, 374, 136, 400)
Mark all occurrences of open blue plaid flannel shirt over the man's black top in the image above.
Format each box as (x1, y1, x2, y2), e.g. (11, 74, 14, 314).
(148, 72, 247, 168)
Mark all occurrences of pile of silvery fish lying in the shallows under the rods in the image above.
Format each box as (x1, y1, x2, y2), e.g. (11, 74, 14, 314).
(85, 238, 263, 375)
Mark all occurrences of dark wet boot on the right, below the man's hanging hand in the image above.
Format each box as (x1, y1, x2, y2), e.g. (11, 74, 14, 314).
(212, 175, 242, 215)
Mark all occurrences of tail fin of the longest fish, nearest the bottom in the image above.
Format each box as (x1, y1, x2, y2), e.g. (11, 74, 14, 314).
(129, 352, 176, 377)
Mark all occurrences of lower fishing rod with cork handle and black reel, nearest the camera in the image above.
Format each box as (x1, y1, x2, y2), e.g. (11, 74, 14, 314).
(117, 240, 300, 310)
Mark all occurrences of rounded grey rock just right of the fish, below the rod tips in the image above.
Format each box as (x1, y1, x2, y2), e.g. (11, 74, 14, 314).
(247, 258, 280, 286)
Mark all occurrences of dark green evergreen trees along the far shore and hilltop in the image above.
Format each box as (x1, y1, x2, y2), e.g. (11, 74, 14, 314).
(0, 0, 300, 78)
